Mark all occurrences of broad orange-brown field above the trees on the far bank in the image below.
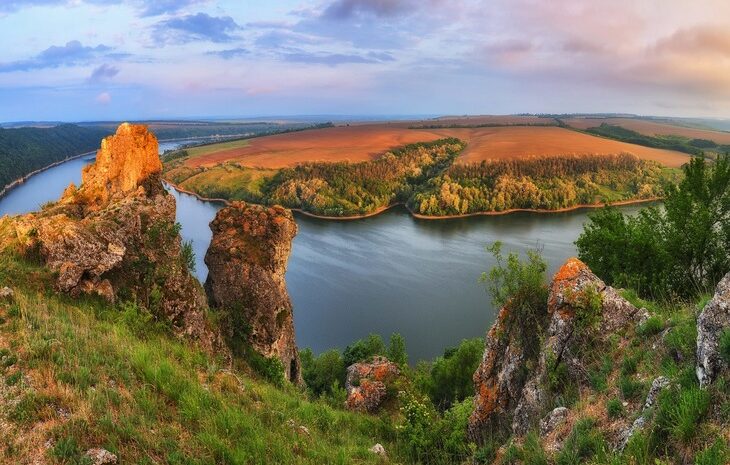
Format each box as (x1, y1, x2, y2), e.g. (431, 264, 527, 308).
(185, 123, 688, 169)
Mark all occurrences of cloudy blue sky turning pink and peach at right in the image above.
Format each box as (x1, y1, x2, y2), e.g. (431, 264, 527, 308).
(0, 0, 730, 122)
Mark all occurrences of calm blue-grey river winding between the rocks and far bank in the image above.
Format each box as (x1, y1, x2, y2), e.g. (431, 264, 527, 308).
(0, 147, 640, 361)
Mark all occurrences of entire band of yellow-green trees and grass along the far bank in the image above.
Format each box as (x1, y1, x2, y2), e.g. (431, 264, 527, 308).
(165, 138, 679, 217)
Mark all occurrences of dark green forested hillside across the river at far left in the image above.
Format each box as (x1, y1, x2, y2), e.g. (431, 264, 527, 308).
(0, 124, 111, 188)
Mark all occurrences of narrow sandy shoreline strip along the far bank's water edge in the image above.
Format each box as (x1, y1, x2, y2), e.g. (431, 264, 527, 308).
(165, 180, 663, 221)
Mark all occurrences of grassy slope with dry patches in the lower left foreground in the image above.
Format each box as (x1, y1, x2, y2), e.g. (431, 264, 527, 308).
(0, 256, 391, 464)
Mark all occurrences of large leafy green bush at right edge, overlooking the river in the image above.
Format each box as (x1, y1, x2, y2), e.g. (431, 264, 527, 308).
(576, 155, 730, 298)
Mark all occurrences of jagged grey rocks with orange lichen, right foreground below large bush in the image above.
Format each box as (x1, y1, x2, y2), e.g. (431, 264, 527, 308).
(469, 258, 645, 441)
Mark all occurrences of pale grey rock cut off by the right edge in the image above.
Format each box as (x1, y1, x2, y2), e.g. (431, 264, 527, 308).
(696, 273, 730, 387)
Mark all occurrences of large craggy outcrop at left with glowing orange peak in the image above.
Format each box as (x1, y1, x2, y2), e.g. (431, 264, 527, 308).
(6, 123, 220, 349)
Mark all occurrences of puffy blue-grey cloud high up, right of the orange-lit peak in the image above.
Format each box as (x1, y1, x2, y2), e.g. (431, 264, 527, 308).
(153, 13, 241, 45)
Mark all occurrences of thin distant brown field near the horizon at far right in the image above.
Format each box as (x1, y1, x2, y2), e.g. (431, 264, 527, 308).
(564, 118, 730, 144)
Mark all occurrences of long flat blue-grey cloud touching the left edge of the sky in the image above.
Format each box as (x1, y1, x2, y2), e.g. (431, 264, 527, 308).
(0, 40, 114, 73)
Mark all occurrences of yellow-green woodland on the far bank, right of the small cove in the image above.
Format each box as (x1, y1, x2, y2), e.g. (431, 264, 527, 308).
(408, 154, 677, 216)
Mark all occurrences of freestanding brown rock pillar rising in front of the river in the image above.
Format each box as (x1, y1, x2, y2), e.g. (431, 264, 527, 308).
(205, 202, 302, 384)
